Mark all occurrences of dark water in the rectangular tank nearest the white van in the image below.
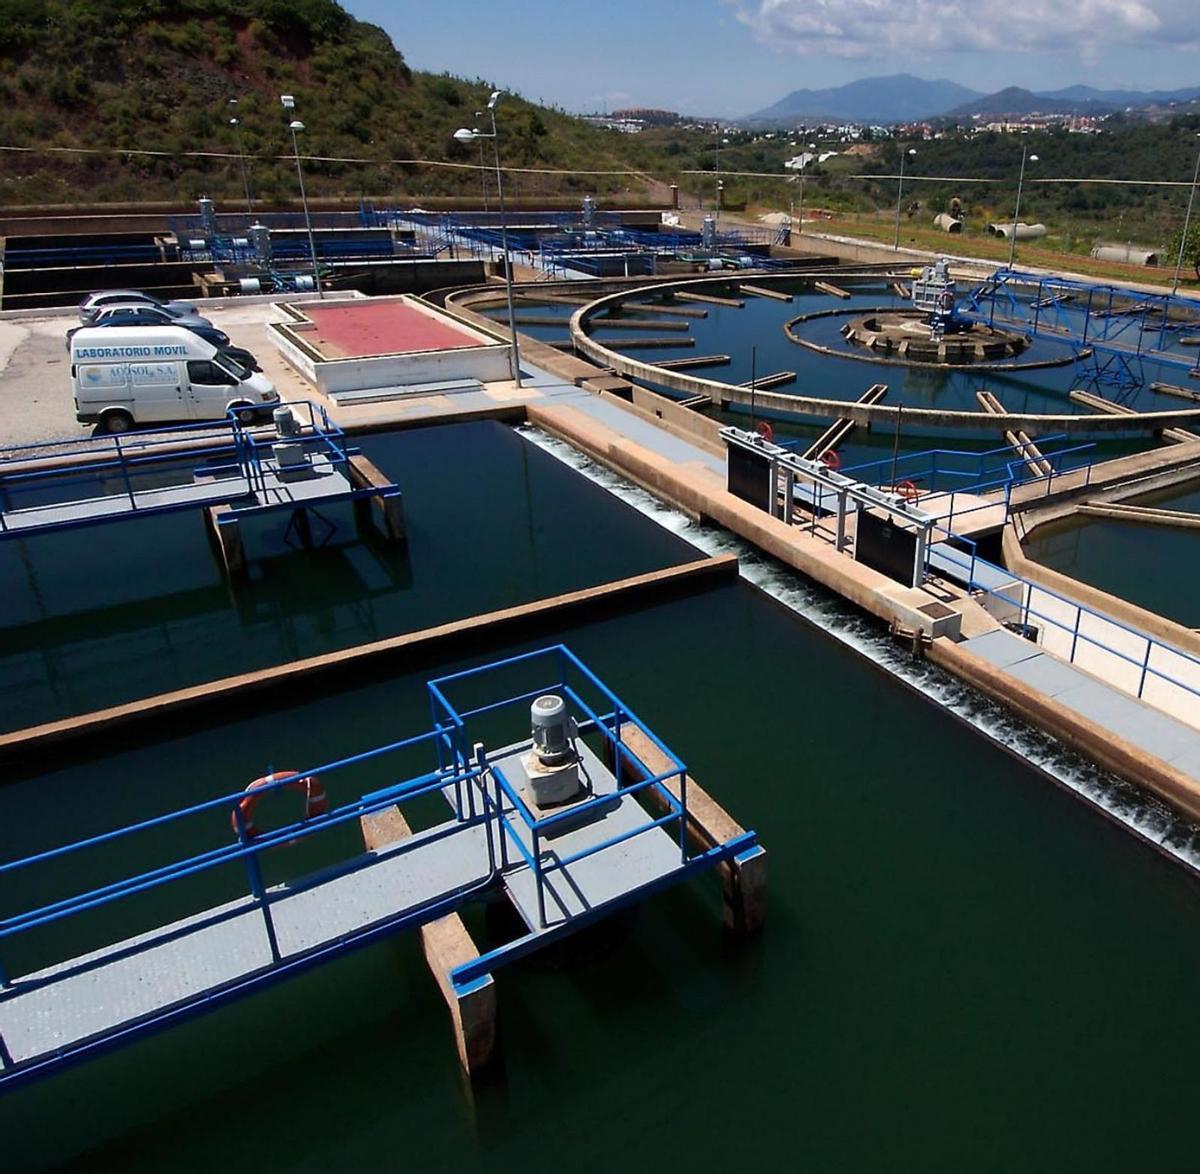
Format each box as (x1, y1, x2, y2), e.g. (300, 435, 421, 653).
(0, 423, 695, 730)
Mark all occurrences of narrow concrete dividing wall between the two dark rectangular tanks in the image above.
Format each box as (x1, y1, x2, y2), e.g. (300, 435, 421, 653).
(0, 555, 738, 771)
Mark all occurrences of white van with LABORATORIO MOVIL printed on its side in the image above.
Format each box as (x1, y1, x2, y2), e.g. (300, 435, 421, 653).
(71, 327, 280, 432)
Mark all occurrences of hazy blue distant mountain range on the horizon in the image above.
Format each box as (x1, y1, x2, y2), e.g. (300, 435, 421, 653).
(742, 73, 1200, 126)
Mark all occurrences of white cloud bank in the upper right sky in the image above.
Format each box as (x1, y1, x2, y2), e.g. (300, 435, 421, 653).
(728, 0, 1200, 59)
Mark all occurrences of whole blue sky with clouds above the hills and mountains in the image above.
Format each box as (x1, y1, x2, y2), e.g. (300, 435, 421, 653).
(343, 0, 1200, 116)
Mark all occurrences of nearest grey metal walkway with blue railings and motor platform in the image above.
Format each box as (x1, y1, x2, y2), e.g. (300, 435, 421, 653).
(0, 646, 761, 1086)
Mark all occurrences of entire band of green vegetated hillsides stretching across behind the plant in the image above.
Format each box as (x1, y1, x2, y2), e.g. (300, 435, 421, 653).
(0, 0, 1200, 279)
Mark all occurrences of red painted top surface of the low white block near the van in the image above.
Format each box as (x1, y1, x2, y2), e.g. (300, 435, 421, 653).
(304, 301, 485, 359)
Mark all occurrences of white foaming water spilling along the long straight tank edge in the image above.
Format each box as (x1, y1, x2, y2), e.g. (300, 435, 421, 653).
(518, 426, 1200, 871)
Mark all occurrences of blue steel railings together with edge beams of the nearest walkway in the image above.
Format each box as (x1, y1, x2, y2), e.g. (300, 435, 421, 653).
(0, 645, 762, 1086)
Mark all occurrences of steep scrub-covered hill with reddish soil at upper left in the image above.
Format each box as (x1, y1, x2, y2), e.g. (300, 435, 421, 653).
(0, 0, 667, 206)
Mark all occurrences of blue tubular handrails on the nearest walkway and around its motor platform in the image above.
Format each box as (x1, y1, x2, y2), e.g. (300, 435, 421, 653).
(0, 645, 705, 999)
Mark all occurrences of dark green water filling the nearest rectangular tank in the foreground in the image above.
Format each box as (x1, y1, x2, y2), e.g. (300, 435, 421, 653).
(0, 585, 1200, 1174)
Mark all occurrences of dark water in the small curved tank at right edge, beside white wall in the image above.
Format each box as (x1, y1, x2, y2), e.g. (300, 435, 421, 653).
(1025, 475, 1200, 628)
